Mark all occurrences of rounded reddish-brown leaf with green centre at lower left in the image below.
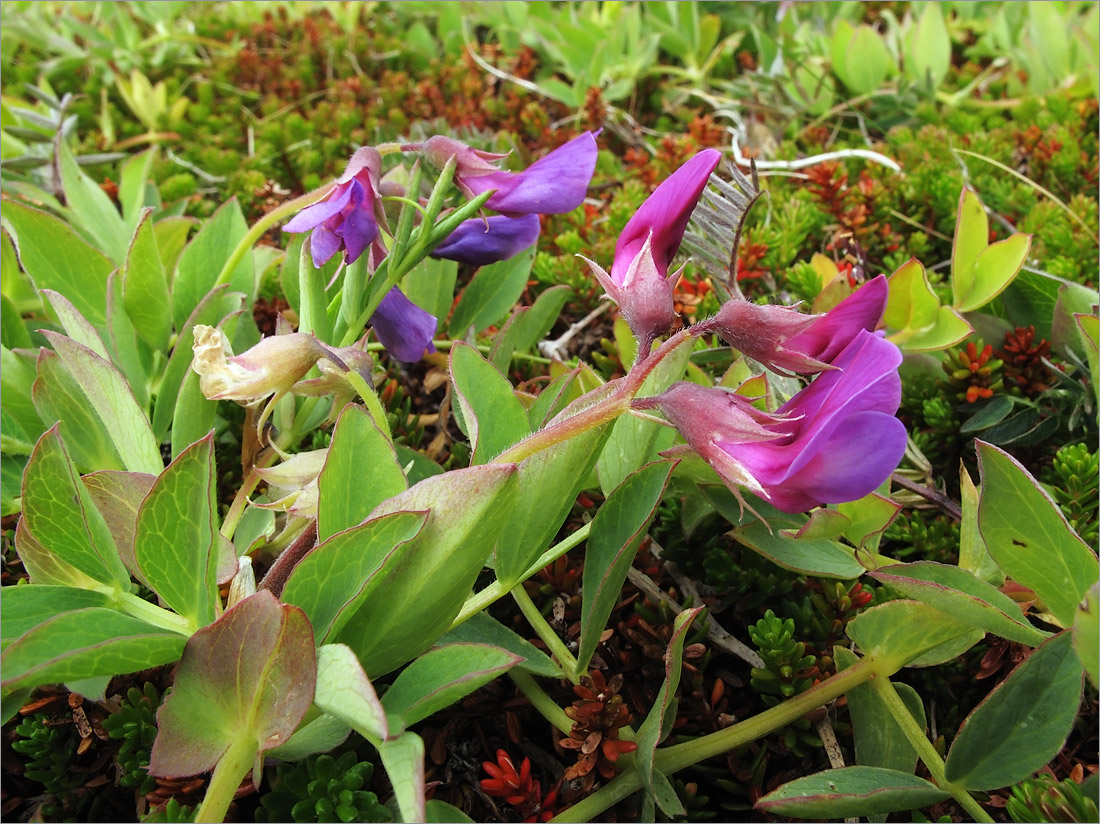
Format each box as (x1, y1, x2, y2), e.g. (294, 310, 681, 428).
(149, 592, 317, 778)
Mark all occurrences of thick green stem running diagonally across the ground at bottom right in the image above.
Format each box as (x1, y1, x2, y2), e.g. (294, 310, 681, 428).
(551, 658, 886, 822)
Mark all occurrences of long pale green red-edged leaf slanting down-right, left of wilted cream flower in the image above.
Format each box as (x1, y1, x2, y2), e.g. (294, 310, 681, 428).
(43, 331, 164, 475)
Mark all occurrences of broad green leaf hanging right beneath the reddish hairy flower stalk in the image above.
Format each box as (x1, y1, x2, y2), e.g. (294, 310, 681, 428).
(495, 418, 609, 589)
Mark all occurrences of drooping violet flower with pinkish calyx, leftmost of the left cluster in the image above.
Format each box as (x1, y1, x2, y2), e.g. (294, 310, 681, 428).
(283, 146, 382, 267)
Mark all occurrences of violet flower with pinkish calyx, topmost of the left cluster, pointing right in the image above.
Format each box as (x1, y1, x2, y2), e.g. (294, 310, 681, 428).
(425, 132, 598, 217)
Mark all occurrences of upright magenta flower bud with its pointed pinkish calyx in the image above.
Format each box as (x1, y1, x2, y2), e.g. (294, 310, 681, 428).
(584, 149, 722, 355)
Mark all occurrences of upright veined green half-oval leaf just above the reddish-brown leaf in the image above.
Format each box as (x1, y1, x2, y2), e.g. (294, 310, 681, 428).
(134, 433, 221, 628)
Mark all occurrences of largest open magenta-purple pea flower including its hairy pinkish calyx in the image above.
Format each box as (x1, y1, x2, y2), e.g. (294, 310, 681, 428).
(655, 330, 905, 513)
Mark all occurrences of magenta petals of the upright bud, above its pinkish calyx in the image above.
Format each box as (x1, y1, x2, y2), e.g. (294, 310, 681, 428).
(612, 149, 722, 284)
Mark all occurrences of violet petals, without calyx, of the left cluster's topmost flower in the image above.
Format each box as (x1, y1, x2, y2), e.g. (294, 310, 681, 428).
(463, 132, 598, 217)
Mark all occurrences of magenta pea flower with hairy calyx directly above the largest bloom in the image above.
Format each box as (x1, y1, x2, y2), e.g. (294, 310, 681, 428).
(695, 275, 889, 374)
